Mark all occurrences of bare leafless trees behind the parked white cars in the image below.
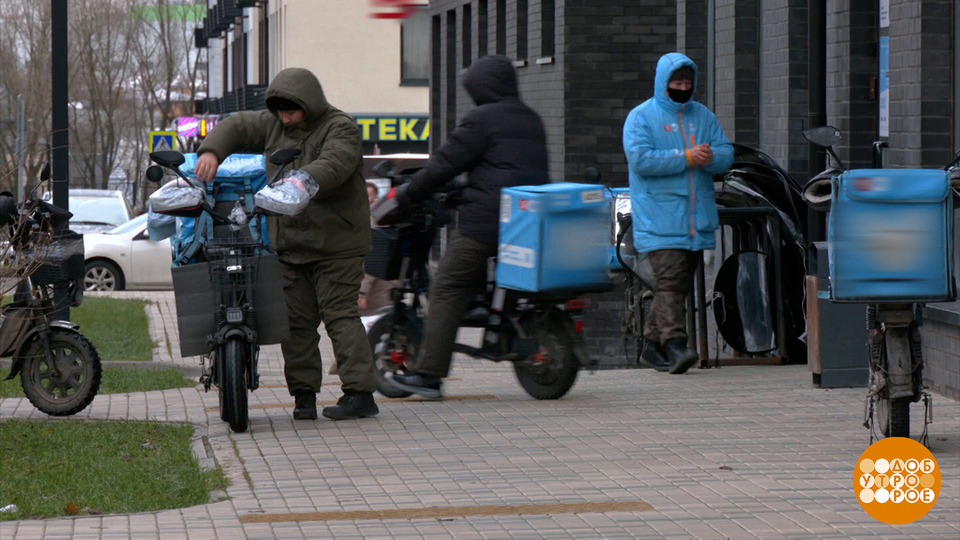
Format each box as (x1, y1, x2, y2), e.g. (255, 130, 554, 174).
(0, 0, 206, 206)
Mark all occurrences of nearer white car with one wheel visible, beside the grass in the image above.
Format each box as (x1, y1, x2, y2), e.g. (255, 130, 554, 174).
(83, 214, 173, 291)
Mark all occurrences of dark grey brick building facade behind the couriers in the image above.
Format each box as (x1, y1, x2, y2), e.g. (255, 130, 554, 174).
(431, 0, 960, 384)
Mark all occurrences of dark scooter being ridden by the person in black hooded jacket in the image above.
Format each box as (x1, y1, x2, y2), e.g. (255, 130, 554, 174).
(365, 161, 595, 399)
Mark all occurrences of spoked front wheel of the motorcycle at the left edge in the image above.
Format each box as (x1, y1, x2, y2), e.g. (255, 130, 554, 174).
(20, 328, 102, 416)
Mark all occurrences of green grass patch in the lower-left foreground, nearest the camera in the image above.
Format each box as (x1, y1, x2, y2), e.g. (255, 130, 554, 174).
(0, 420, 226, 520)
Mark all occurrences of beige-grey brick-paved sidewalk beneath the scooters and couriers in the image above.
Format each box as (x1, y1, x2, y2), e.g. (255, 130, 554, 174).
(0, 292, 960, 540)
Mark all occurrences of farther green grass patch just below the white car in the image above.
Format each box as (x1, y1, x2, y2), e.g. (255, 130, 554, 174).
(70, 296, 154, 361)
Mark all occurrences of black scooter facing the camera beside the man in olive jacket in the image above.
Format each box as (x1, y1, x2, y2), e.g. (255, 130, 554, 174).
(146, 149, 301, 433)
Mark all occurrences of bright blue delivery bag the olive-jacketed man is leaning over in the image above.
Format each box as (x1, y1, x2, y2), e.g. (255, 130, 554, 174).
(170, 154, 267, 266)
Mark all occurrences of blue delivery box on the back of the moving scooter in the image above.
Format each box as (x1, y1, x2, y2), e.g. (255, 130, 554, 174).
(497, 182, 610, 292)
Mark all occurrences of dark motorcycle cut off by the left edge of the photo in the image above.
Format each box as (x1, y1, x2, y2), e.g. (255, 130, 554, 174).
(0, 164, 102, 416)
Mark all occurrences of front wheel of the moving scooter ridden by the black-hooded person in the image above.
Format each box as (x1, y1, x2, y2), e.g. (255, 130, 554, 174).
(367, 308, 423, 398)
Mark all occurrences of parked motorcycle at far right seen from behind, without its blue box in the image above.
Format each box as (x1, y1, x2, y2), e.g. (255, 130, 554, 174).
(803, 126, 960, 444)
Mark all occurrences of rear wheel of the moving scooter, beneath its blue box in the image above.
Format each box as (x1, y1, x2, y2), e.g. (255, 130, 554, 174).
(513, 311, 580, 399)
